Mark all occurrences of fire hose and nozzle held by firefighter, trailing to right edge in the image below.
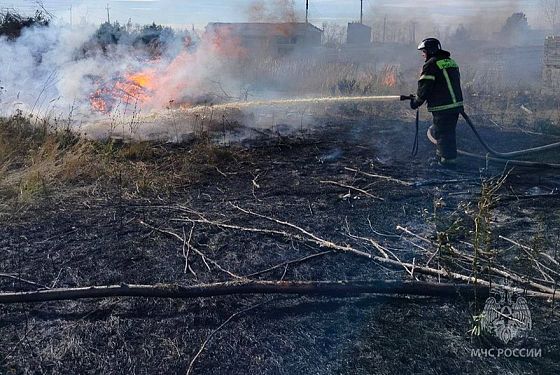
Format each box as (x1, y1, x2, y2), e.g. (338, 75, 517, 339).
(400, 95, 560, 169)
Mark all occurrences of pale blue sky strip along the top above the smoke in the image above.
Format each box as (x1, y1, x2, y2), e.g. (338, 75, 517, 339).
(0, 0, 539, 27)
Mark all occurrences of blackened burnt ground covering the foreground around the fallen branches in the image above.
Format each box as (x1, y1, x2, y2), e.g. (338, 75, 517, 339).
(0, 113, 560, 374)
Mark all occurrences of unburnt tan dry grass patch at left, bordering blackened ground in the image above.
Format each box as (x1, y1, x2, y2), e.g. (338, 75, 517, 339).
(0, 114, 238, 217)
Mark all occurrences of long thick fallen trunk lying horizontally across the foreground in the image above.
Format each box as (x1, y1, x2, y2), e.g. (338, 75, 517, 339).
(0, 280, 553, 304)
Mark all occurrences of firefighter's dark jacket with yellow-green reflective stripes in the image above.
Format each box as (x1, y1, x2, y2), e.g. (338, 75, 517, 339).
(416, 50, 463, 112)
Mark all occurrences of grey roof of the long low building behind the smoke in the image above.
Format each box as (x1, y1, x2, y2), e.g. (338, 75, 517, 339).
(206, 22, 323, 37)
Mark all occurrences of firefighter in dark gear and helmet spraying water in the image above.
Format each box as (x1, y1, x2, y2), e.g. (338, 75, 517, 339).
(410, 38, 464, 168)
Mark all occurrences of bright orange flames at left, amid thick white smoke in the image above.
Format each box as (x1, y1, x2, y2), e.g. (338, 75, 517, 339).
(90, 71, 155, 113)
